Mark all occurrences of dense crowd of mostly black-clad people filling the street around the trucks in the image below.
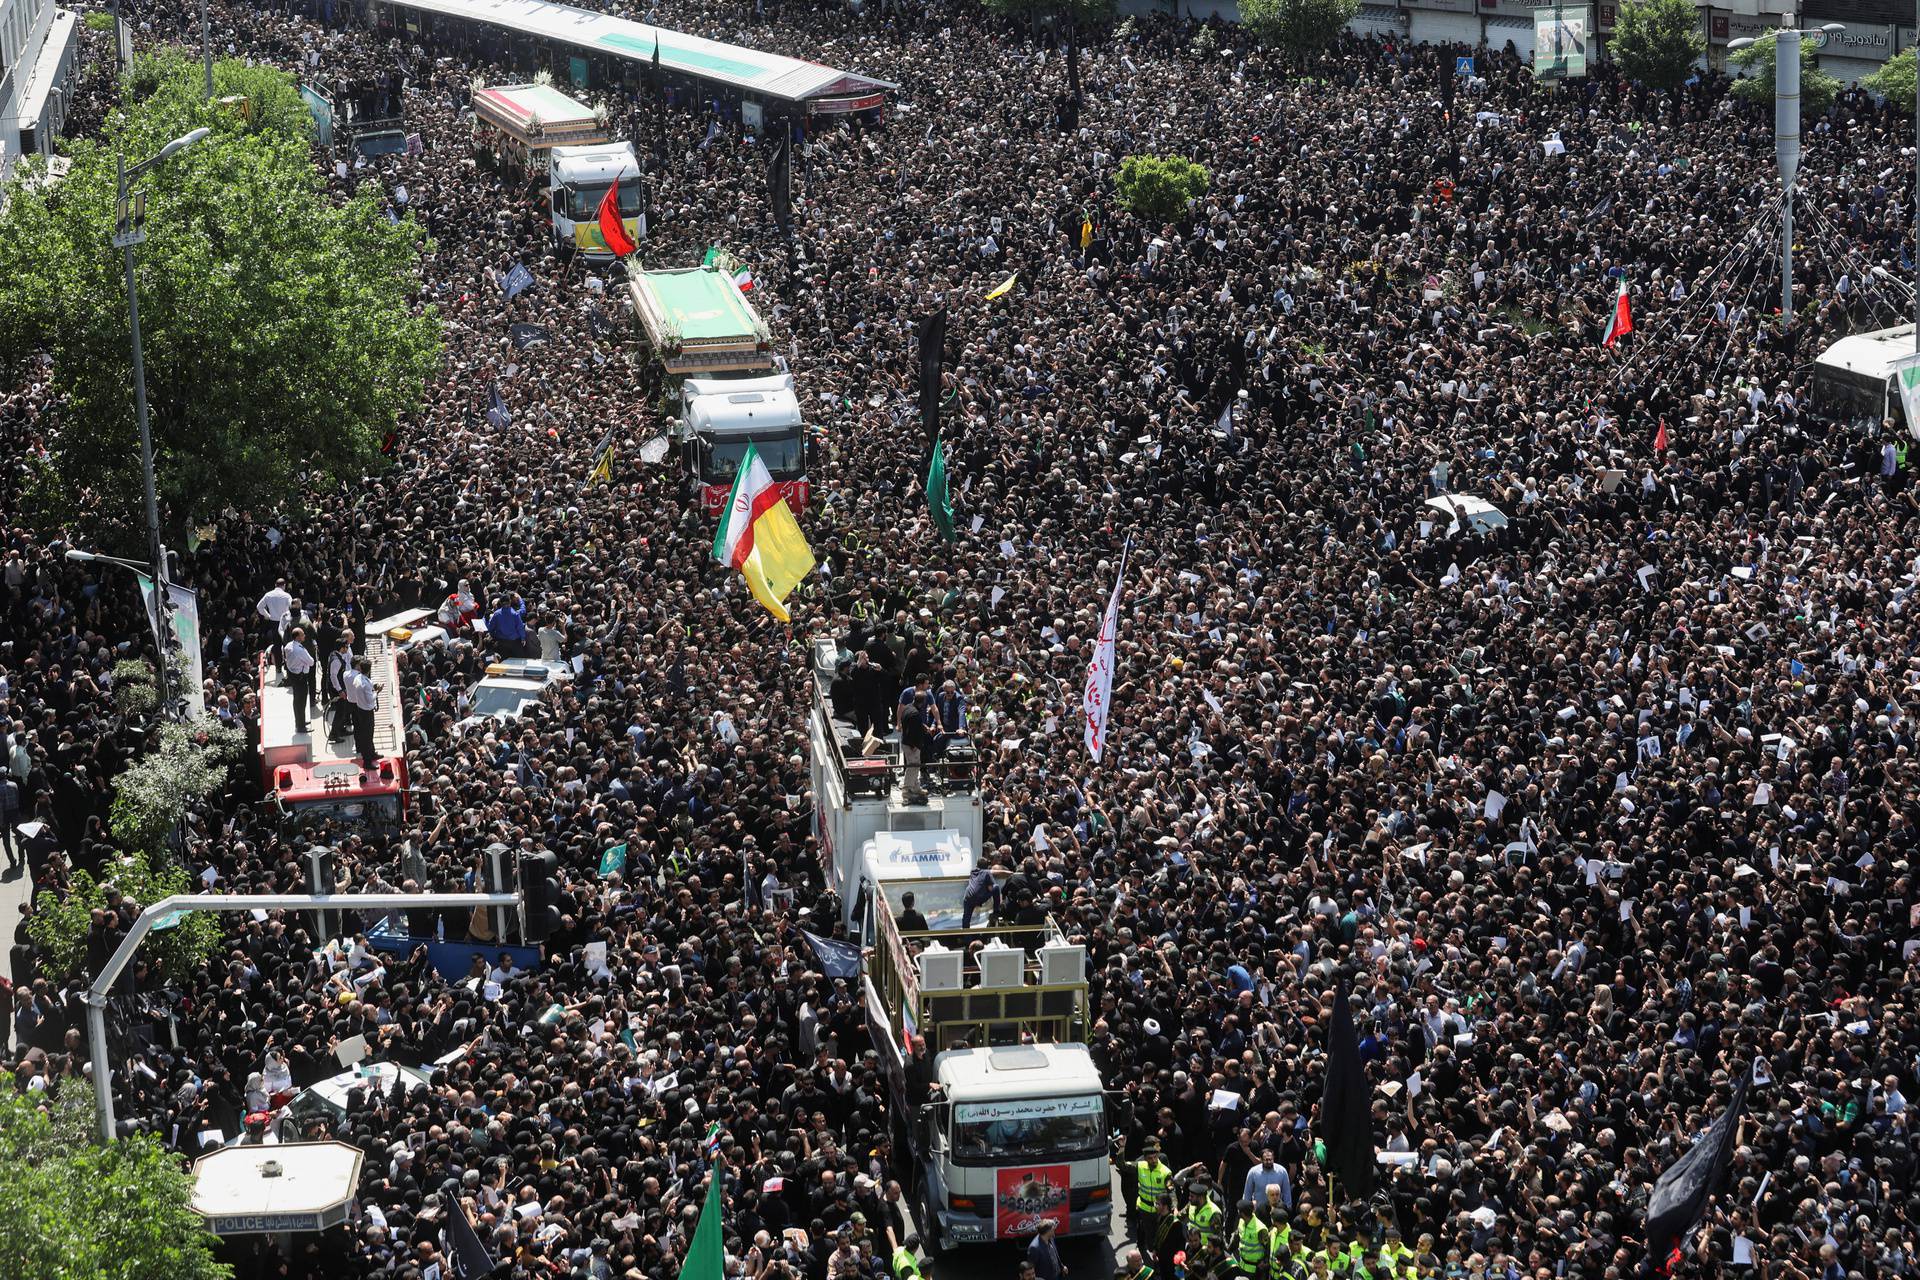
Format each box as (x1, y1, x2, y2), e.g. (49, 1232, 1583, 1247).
(0, 0, 1920, 1280)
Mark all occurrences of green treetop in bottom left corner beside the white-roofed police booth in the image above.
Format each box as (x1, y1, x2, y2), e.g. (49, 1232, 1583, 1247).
(0, 1084, 232, 1280)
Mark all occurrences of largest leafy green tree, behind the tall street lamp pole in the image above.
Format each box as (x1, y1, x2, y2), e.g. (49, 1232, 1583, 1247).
(0, 54, 440, 547)
